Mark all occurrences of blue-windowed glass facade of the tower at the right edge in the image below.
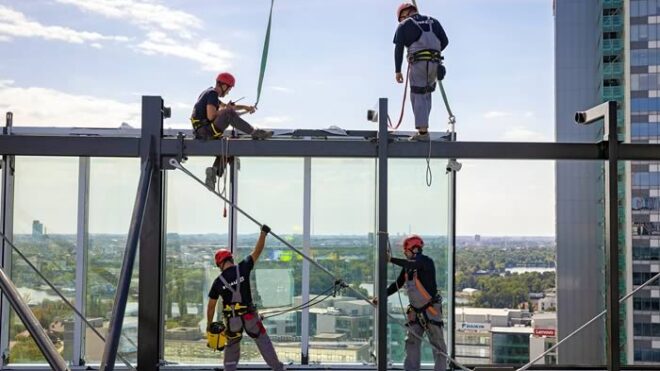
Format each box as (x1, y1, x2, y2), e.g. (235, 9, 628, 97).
(629, 0, 660, 364)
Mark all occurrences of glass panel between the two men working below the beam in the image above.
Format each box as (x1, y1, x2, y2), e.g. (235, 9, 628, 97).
(309, 159, 376, 364)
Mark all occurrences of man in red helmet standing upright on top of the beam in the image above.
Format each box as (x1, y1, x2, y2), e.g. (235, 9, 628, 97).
(394, 3, 449, 140)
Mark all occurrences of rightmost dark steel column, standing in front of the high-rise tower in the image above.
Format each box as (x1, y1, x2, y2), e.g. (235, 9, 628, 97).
(604, 101, 621, 371)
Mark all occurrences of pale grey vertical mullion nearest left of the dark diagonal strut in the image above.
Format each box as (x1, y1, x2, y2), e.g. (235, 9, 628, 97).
(71, 157, 90, 366)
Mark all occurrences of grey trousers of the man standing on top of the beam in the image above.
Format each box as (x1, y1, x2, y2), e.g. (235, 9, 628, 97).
(409, 61, 438, 131)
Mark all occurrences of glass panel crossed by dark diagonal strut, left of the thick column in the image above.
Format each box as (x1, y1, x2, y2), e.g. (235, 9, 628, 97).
(85, 158, 140, 365)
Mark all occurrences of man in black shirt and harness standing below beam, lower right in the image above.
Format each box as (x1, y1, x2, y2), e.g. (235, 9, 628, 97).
(373, 235, 447, 371)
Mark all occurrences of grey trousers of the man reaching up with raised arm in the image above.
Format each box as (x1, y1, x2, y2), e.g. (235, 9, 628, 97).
(224, 313, 284, 371)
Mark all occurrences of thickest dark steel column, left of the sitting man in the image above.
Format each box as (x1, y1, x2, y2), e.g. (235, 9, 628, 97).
(138, 96, 165, 371)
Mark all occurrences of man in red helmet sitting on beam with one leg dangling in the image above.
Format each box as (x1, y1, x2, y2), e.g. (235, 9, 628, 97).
(190, 72, 273, 189)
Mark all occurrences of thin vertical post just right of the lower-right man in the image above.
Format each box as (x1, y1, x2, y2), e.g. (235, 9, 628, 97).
(445, 132, 457, 369)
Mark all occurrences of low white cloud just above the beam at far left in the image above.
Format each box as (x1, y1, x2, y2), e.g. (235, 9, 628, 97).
(0, 80, 140, 128)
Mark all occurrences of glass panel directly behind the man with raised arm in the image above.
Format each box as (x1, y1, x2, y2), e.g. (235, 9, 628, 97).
(235, 158, 303, 365)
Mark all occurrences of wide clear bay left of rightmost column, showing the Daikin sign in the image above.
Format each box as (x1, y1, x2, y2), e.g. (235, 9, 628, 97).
(455, 160, 605, 365)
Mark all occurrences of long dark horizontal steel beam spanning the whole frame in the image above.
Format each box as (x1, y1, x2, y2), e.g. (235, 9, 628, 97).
(0, 135, 660, 161)
